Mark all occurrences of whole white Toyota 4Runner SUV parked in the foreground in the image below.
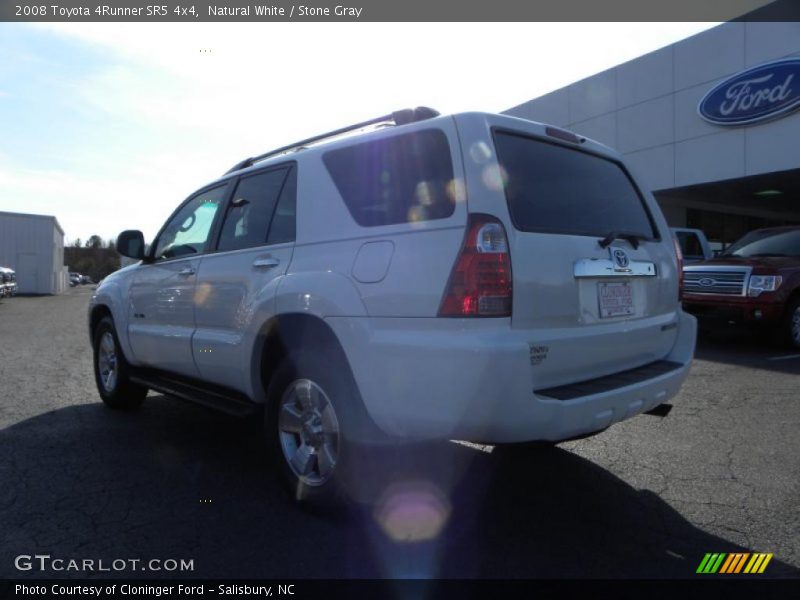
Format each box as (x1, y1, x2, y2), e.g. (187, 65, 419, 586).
(89, 108, 696, 498)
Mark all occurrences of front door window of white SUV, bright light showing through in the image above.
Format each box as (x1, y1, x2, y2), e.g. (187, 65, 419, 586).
(153, 185, 227, 260)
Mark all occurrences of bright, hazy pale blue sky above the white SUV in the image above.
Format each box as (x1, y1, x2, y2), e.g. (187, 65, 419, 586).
(0, 23, 716, 242)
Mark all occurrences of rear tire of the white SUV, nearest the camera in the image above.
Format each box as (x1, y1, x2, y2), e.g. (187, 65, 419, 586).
(264, 350, 391, 508)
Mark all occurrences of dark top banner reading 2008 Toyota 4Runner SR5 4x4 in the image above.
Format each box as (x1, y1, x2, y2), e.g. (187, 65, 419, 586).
(0, 0, 800, 23)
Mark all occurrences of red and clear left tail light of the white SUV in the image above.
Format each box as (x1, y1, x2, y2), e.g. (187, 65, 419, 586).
(439, 214, 511, 317)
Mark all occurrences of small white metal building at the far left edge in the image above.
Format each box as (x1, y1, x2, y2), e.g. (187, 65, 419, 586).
(0, 212, 68, 294)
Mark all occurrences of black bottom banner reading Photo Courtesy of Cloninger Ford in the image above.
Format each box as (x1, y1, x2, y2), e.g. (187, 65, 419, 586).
(0, 576, 800, 600)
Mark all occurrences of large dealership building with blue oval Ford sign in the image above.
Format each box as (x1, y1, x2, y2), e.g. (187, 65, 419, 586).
(506, 22, 800, 248)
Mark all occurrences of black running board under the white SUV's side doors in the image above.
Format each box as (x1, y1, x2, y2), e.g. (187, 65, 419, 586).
(130, 371, 259, 417)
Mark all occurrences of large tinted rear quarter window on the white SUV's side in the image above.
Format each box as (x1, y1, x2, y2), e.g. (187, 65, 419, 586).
(323, 129, 455, 227)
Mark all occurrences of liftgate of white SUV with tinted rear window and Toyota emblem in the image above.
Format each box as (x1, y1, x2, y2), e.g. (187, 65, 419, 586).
(460, 116, 678, 386)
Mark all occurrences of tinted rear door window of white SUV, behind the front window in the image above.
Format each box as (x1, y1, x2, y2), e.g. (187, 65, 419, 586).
(217, 169, 288, 251)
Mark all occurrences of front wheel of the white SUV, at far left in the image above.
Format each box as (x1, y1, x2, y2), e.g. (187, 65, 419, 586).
(92, 316, 147, 410)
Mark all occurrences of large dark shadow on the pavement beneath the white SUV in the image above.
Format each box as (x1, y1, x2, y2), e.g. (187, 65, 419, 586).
(0, 396, 800, 578)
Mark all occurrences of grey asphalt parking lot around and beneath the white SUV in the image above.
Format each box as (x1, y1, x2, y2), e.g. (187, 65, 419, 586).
(0, 286, 800, 578)
